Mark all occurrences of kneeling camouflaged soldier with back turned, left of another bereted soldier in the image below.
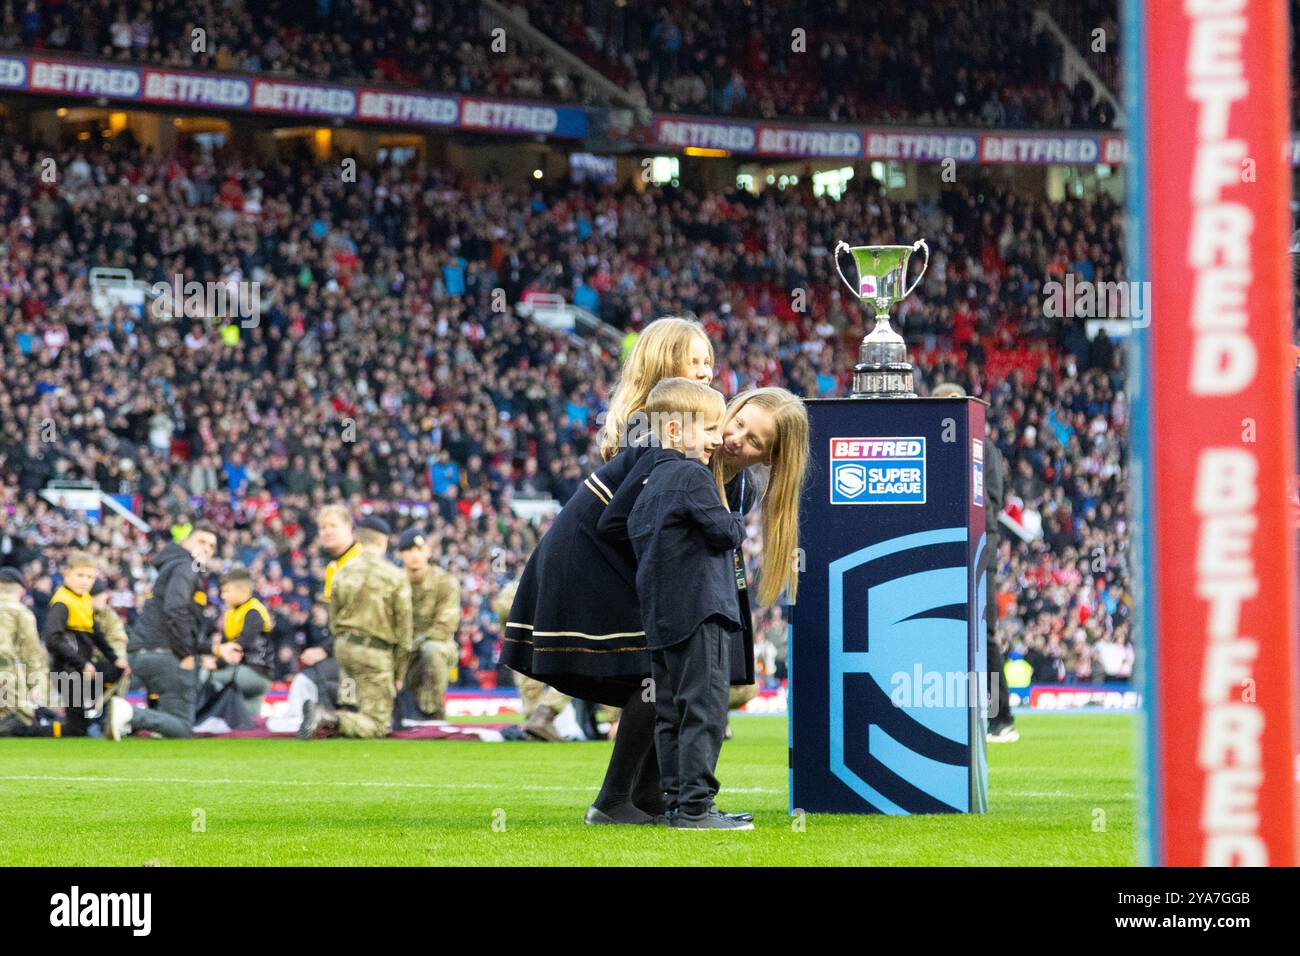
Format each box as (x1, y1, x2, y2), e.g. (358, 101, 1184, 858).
(298, 518, 412, 740)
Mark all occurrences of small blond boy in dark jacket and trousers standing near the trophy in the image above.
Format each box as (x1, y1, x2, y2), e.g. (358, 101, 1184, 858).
(627, 378, 754, 830)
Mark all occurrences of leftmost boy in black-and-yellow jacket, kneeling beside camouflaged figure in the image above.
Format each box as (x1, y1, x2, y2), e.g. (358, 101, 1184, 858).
(40, 551, 127, 737)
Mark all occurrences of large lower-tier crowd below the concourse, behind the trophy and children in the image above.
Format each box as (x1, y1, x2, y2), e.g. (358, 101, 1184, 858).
(0, 125, 1131, 723)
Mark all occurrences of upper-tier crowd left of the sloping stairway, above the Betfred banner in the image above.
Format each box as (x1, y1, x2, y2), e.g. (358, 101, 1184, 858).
(0, 0, 593, 103)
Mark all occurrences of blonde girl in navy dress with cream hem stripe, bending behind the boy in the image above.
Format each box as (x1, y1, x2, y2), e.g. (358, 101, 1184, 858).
(502, 317, 714, 823)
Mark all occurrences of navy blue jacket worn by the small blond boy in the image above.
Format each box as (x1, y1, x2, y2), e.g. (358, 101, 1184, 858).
(597, 449, 745, 649)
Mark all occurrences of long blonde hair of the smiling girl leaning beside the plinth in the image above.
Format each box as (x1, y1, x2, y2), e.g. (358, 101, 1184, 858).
(714, 388, 809, 605)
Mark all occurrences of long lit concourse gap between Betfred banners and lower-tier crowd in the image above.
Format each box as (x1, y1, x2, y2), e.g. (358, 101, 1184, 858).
(0, 96, 1123, 202)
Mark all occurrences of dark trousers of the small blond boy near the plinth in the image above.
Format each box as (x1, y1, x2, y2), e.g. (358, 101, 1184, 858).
(650, 618, 736, 817)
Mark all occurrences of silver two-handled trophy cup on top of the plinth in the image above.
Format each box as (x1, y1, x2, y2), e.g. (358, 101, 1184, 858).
(835, 239, 930, 398)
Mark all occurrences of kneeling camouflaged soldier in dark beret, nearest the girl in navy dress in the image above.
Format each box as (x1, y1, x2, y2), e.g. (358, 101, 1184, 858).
(398, 528, 460, 721)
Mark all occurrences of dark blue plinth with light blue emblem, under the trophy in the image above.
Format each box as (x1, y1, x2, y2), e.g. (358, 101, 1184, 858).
(789, 398, 982, 814)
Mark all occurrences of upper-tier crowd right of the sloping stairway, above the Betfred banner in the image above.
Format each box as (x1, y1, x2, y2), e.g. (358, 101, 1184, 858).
(529, 0, 1114, 129)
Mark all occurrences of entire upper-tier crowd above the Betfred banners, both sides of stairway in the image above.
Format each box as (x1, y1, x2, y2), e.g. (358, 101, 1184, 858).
(0, 0, 1114, 129)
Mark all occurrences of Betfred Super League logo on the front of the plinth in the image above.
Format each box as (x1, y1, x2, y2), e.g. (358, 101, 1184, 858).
(831, 437, 926, 505)
